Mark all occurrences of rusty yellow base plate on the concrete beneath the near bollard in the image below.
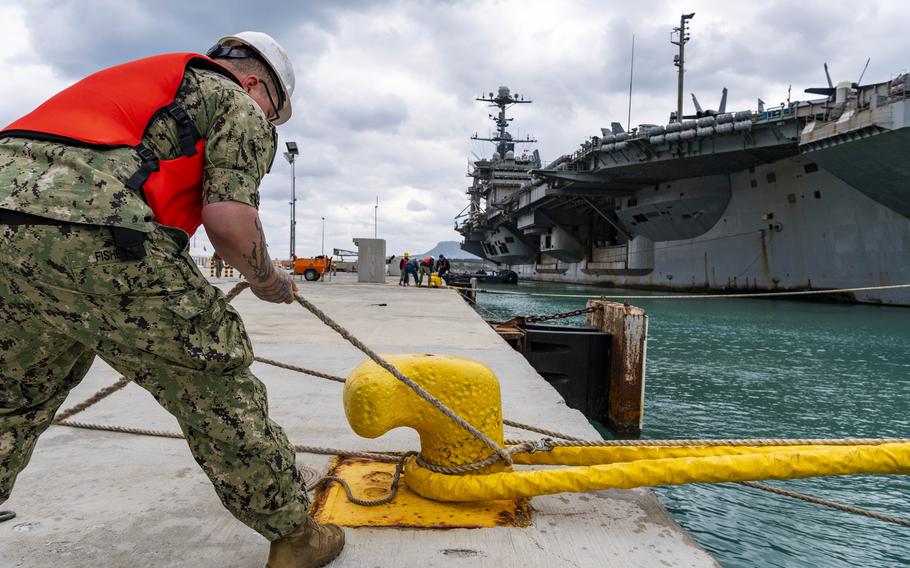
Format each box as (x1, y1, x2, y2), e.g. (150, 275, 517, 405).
(312, 458, 531, 528)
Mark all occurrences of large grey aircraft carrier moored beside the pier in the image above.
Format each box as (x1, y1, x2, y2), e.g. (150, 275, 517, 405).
(456, 14, 910, 306)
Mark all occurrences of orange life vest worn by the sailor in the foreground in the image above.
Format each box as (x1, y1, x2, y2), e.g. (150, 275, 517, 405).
(0, 53, 236, 235)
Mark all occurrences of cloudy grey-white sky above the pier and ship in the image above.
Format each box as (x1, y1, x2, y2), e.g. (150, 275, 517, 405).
(0, 0, 910, 257)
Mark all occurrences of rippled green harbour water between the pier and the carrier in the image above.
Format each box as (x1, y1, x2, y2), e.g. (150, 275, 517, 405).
(478, 283, 910, 568)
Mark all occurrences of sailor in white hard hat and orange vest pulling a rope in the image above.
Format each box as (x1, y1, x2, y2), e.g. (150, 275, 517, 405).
(0, 32, 344, 568)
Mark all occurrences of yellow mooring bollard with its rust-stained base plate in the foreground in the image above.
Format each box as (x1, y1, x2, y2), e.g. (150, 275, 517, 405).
(311, 355, 531, 528)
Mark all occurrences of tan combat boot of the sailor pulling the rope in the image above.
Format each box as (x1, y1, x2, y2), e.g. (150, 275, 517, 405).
(266, 515, 344, 568)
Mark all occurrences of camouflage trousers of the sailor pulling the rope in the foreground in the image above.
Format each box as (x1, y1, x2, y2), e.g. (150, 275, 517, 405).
(0, 221, 308, 540)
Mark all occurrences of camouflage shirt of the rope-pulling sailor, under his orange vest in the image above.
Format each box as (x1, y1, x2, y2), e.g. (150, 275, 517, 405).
(0, 69, 276, 232)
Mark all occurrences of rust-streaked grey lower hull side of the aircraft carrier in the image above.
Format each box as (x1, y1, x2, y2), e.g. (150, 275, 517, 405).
(511, 152, 910, 306)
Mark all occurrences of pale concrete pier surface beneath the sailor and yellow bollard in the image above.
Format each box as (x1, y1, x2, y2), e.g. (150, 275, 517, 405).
(0, 274, 716, 568)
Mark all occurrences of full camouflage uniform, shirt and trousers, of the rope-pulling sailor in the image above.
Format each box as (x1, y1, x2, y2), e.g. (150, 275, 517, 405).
(0, 70, 308, 540)
